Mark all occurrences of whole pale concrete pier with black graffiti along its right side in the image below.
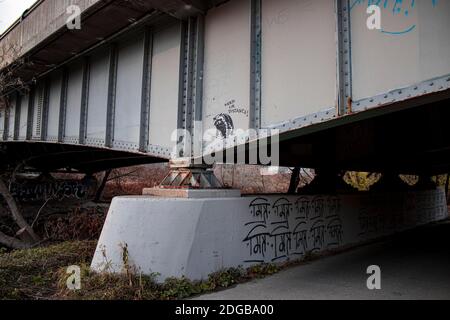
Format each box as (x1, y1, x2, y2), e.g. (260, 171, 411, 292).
(91, 189, 448, 281)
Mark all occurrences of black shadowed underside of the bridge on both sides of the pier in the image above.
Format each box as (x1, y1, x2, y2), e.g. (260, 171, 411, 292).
(0, 92, 450, 174)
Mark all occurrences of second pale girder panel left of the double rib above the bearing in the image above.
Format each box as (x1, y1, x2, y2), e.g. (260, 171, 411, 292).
(114, 37, 144, 149)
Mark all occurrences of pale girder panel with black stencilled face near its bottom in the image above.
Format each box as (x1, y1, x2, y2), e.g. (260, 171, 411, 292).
(203, 0, 251, 134)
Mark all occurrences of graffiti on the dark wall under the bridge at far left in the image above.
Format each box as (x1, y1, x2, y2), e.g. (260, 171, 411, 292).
(10, 179, 94, 202)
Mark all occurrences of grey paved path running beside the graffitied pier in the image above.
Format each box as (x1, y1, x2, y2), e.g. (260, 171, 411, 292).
(197, 223, 450, 300)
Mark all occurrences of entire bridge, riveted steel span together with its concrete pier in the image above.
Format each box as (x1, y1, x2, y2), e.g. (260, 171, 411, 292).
(0, 0, 450, 279)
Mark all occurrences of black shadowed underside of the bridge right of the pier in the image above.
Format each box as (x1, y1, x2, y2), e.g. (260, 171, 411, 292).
(220, 92, 450, 174)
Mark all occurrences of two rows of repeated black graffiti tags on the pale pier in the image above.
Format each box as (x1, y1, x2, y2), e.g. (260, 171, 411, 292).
(243, 196, 344, 263)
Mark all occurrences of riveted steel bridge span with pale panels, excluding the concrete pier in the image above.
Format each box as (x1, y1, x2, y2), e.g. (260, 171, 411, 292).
(0, 0, 450, 173)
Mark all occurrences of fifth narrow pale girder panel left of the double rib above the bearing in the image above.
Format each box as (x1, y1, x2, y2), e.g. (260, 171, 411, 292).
(47, 72, 62, 141)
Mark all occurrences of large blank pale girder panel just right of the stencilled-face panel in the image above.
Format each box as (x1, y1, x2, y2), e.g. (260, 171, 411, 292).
(261, 0, 337, 127)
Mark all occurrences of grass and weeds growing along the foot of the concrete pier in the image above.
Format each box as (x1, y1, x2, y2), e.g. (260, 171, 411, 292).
(0, 241, 322, 300)
